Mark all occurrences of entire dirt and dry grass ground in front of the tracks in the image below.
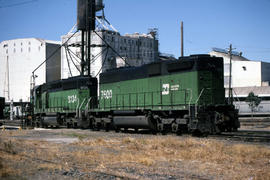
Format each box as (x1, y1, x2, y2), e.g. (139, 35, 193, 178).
(0, 129, 270, 180)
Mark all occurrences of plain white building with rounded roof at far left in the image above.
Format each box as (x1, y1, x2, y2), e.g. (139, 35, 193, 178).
(0, 38, 61, 102)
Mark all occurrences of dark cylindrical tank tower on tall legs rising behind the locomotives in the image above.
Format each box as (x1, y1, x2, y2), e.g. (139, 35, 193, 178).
(77, 0, 96, 76)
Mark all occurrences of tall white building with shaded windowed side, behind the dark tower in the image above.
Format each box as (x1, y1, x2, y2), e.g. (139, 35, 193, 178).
(61, 30, 158, 79)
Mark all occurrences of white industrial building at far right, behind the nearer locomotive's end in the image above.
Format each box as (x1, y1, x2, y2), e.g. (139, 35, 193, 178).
(209, 48, 270, 115)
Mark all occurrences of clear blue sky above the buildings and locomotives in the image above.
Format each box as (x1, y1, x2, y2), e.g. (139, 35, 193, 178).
(0, 0, 270, 62)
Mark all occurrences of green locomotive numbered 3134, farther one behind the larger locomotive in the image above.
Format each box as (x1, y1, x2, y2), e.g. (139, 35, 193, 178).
(31, 76, 97, 127)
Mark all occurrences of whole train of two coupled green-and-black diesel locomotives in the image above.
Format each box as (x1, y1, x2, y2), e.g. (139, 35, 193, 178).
(32, 55, 240, 134)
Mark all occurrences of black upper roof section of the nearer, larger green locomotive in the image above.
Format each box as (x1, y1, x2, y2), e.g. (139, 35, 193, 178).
(100, 55, 223, 84)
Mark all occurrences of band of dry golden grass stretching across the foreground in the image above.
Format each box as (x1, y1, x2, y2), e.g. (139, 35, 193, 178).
(0, 131, 270, 180)
